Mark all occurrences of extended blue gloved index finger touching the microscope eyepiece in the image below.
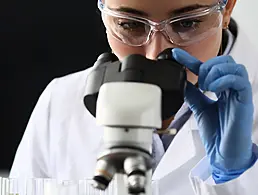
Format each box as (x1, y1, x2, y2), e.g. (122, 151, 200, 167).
(172, 48, 202, 75)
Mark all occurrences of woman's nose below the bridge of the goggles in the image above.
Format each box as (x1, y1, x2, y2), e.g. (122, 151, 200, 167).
(145, 32, 175, 60)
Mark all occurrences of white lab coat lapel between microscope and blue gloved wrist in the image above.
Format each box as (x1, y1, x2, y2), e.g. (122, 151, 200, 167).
(152, 116, 205, 195)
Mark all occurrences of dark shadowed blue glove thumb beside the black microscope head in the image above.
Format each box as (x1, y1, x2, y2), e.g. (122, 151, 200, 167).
(185, 82, 213, 115)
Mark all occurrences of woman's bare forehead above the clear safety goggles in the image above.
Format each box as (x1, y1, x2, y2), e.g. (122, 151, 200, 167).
(104, 0, 219, 19)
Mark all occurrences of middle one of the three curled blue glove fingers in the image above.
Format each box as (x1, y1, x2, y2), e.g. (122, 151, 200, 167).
(204, 63, 248, 91)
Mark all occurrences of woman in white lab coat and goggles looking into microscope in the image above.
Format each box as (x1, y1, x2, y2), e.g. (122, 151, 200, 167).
(10, 0, 258, 195)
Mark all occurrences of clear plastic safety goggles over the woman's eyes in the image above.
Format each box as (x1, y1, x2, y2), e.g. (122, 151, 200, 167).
(98, 0, 226, 46)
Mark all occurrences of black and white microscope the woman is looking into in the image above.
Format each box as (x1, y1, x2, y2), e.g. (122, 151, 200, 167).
(84, 48, 186, 195)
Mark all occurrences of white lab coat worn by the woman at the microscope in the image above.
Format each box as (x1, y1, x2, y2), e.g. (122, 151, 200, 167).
(10, 22, 258, 195)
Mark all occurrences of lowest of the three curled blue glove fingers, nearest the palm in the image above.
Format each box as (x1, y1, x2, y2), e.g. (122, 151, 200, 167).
(208, 75, 252, 103)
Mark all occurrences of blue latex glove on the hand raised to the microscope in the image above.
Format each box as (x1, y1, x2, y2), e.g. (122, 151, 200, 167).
(172, 48, 257, 183)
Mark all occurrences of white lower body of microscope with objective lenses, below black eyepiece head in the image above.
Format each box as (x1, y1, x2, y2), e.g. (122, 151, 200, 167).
(94, 82, 162, 195)
